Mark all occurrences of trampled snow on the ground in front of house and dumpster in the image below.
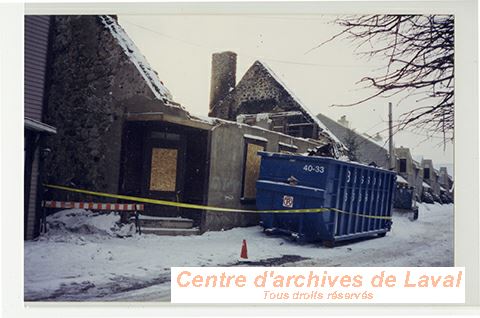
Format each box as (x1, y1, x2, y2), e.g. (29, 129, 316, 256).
(24, 204, 453, 301)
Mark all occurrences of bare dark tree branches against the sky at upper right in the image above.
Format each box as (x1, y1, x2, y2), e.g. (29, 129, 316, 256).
(314, 15, 454, 140)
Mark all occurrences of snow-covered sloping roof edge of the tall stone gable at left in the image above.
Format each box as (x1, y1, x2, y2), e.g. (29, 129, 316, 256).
(100, 15, 174, 103)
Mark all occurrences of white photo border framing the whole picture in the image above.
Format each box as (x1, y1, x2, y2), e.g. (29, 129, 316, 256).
(0, 0, 480, 317)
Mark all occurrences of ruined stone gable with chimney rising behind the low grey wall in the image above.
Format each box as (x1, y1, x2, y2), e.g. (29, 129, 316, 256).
(209, 52, 342, 151)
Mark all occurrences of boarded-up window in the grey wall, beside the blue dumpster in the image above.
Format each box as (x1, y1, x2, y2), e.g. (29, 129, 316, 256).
(243, 142, 265, 199)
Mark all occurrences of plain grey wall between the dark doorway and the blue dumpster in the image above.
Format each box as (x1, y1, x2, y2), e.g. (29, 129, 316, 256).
(204, 123, 316, 230)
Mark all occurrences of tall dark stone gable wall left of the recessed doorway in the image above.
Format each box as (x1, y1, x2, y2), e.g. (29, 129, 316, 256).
(45, 15, 172, 199)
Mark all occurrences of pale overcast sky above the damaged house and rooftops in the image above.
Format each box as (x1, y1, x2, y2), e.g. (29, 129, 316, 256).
(119, 15, 453, 172)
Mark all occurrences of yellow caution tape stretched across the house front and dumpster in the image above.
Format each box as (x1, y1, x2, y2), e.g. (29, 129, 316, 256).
(44, 184, 392, 220)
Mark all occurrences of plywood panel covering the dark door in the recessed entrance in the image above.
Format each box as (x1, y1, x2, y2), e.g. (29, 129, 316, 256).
(150, 148, 178, 192)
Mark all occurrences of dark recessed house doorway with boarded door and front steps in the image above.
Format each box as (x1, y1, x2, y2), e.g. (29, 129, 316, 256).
(120, 121, 209, 226)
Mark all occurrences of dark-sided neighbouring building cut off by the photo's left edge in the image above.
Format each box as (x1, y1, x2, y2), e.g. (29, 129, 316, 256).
(24, 16, 56, 239)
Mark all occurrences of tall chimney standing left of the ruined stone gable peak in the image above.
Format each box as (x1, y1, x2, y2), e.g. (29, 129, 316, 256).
(209, 51, 237, 117)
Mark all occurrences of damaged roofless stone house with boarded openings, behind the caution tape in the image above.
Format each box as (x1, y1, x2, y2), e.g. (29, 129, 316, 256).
(26, 16, 341, 235)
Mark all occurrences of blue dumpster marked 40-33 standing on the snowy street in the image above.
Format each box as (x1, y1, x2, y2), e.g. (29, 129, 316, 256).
(256, 152, 396, 246)
